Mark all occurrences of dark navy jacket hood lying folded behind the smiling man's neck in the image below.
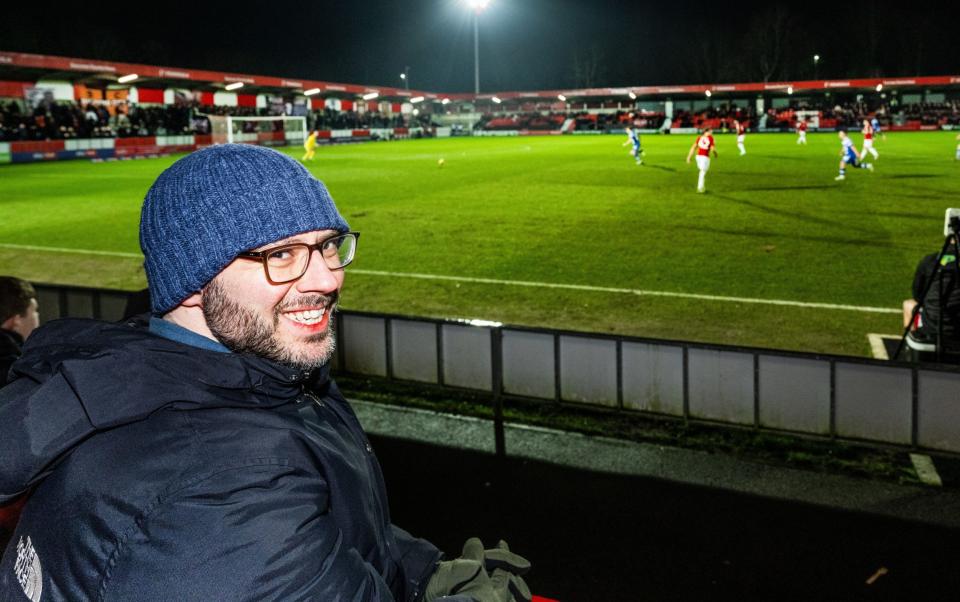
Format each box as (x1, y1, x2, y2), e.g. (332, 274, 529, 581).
(0, 319, 329, 503)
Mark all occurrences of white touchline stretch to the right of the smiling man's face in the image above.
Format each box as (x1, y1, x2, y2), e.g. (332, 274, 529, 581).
(350, 269, 901, 314)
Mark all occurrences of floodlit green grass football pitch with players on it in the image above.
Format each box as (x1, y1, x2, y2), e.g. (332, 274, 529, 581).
(0, 132, 960, 355)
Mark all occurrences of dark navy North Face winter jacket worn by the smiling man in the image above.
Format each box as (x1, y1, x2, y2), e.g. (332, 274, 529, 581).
(0, 320, 440, 602)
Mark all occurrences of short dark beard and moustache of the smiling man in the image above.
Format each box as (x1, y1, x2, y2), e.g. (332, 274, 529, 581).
(203, 279, 339, 370)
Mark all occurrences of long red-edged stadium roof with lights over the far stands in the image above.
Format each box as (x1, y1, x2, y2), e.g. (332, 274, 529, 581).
(0, 51, 960, 101)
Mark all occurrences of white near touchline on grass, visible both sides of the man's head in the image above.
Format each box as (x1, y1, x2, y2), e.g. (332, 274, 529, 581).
(0, 243, 901, 314)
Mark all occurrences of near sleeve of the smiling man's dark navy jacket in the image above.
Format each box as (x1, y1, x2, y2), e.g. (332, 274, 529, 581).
(98, 464, 402, 602)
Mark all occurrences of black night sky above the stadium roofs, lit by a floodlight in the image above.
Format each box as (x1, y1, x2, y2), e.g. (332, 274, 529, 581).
(0, 0, 960, 92)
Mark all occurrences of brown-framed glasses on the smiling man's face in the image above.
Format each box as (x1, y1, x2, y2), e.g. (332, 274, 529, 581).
(237, 232, 360, 284)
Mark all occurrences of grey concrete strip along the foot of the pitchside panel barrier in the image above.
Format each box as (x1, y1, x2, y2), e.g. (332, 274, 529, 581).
(351, 400, 960, 528)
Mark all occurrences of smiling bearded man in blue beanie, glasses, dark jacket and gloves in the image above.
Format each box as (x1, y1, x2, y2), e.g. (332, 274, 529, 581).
(0, 144, 530, 602)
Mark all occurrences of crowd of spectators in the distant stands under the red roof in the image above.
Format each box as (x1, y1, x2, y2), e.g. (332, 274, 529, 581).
(7, 99, 960, 142)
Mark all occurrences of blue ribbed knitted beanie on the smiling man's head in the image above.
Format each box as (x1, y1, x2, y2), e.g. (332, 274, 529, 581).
(140, 144, 350, 315)
